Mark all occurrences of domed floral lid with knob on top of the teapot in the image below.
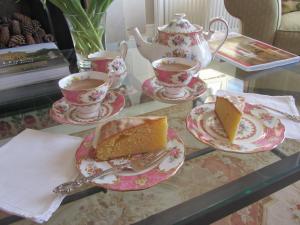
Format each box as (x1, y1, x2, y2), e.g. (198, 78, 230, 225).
(158, 13, 200, 33)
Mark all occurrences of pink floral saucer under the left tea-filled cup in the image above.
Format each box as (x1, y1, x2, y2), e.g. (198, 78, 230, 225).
(50, 91, 125, 125)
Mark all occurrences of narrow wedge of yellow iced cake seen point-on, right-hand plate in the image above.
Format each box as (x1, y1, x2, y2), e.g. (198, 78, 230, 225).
(215, 96, 245, 143)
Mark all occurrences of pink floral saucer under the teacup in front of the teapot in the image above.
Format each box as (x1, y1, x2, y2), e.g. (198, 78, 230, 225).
(142, 77, 207, 104)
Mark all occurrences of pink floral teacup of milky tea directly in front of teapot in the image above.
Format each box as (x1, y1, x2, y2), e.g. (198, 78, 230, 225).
(152, 57, 201, 98)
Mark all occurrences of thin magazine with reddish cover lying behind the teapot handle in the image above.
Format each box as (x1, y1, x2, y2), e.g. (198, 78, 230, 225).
(210, 33, 300, 71)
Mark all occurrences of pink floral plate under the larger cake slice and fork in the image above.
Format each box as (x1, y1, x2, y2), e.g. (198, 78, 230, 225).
(75, 129, 184, 191)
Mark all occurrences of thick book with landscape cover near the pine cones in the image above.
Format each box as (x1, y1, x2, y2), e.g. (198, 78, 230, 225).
(0, 43, 70, 90)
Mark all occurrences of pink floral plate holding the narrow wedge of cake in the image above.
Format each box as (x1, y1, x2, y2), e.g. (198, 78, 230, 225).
(186, 103, 285, 153)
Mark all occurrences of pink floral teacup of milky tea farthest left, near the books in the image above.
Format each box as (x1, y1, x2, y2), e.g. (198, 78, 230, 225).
(58, 71, 111, 119)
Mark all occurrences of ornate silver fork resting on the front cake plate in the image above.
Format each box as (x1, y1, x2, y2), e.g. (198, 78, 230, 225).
(53, 150, 169, 194)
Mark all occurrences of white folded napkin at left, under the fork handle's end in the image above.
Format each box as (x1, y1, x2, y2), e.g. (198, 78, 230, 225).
(0, 129, 81, 223)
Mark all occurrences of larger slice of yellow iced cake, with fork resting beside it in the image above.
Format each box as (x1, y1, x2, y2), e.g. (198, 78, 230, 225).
(93, 116, 168, 161)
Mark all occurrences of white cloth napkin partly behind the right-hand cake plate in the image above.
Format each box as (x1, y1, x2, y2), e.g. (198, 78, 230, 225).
(216, 90, 300, 140)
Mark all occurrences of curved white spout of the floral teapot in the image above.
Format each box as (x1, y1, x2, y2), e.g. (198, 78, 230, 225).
(128, 27, 155, 61)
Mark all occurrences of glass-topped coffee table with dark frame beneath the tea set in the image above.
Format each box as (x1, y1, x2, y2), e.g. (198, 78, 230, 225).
(0, 44, 300, 225)
